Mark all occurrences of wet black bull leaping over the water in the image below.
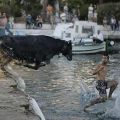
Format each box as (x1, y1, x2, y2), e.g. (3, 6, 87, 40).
(0, 35, 72, 69)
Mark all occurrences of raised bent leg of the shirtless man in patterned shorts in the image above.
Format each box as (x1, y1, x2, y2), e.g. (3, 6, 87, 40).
(107, 80, 118, 98)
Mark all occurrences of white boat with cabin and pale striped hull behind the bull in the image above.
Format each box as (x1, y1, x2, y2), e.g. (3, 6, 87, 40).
(53, 21, 106, 54)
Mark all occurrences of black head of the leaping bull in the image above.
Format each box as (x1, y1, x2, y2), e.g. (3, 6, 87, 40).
(62, 41, 72, 61)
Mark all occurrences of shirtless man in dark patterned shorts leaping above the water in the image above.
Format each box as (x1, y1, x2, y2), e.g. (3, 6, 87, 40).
(84, 54, 118, 111)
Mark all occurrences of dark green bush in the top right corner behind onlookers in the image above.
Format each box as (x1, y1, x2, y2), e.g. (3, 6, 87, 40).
(97, 2, 120, 24)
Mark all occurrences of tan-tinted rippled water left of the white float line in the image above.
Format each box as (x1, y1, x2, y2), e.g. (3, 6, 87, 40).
(0, 70, 38, 120)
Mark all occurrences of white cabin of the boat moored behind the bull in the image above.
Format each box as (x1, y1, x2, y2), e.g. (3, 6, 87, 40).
(53, 21, 99, 42)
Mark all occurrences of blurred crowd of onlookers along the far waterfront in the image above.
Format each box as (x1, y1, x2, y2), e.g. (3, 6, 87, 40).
(0, 4, 120, 31)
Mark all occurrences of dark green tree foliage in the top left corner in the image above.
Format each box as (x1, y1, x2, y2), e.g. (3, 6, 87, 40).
(0, 0, 42, 17)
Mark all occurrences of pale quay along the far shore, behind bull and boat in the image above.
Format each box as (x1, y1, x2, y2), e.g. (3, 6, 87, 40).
(11, 23, 120, 39)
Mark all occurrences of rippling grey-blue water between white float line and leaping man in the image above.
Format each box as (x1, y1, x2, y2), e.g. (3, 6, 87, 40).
(10, 54, 120, 120)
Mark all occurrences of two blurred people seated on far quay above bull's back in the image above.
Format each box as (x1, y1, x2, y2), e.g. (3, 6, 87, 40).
(26, 14, 43, 29)
